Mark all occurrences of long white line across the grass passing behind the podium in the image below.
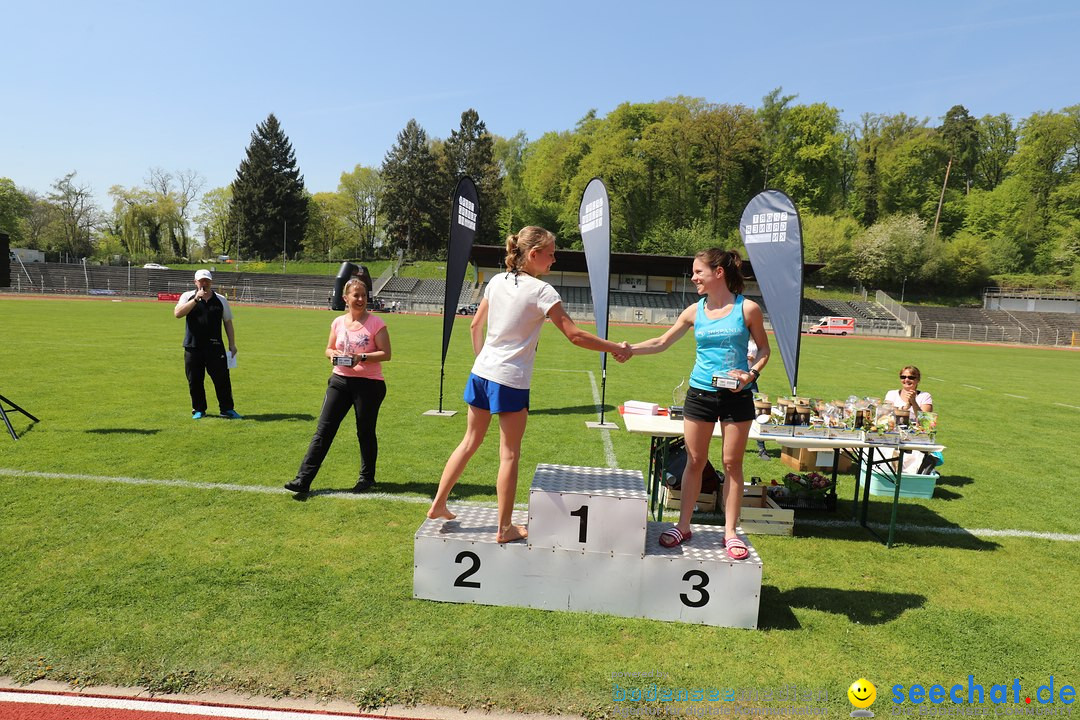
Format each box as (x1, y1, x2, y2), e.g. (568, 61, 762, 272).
(6, 467, 1080, 543)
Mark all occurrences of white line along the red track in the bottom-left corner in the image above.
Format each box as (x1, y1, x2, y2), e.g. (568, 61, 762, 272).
(0, 691, 376, 720)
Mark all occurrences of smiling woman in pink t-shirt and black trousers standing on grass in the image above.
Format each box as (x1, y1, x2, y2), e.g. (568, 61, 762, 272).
(285, 277, 390, 492)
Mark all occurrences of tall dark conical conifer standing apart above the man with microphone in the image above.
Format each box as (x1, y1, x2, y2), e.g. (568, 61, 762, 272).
(230, 117, 308, 260)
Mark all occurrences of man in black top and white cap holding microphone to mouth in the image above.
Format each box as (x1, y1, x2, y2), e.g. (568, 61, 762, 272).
(173, 270, 242, 420)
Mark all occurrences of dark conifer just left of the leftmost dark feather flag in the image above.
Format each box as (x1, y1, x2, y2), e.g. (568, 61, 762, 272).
(382, 120, 440, 255)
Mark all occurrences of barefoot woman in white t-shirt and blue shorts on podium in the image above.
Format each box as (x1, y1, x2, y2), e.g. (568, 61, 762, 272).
(428, 226, 631, 543)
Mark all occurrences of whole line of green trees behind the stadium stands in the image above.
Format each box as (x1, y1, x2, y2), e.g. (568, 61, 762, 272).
(0, 89, 1080, 291)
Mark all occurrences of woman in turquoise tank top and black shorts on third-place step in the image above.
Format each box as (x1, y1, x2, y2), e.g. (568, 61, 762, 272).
(632, 248, 769, 560)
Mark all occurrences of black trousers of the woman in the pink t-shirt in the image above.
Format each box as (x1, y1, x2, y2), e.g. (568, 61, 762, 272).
(296, 373, 387, 485)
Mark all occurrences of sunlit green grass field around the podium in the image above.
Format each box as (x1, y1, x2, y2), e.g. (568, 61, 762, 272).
(0, 297, 1080, 717)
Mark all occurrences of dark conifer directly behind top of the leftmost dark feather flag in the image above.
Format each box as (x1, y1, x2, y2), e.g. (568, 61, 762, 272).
(442, 108, 503, 245)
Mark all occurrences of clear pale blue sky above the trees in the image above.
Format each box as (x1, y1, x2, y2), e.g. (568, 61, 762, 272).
(0, 0, 1080, 205)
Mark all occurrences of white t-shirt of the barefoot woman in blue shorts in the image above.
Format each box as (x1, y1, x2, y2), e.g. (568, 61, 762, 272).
(472, 272, 563, 390)
